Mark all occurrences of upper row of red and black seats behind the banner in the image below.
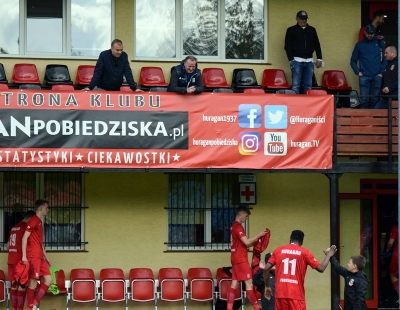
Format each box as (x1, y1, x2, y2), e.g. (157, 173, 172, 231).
(0, 64, 351, 91)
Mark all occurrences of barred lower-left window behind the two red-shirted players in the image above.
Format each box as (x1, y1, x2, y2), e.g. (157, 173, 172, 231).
(0, 172, 85, 251)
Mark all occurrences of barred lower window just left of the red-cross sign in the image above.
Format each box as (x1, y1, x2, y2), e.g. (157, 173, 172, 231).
(167, 174, 244, 250)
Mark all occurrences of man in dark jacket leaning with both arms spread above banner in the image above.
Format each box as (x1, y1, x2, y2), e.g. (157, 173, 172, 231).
(83, 39, 137, 91)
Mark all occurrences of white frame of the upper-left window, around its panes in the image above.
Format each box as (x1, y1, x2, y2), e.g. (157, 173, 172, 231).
(1, 0, 115, 59)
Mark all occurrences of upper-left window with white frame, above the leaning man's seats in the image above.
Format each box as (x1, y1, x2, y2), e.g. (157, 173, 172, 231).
(0, 0, 114, 57)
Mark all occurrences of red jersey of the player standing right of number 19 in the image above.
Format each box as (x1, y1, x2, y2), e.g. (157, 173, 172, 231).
(26, 214, 43, 259)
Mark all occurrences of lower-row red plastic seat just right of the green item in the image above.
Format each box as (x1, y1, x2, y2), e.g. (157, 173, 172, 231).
(69, 268, 97, 302)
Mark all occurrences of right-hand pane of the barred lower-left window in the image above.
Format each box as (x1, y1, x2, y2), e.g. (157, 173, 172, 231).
(44, 172, 82, 249)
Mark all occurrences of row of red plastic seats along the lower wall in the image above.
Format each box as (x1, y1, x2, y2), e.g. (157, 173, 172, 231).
(0, 268, 244, 310)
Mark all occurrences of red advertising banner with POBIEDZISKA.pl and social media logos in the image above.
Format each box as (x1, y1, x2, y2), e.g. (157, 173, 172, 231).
(0, 90, 333, 169)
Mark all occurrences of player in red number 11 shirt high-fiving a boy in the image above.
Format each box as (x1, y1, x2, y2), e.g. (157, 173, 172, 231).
(264, 230, 336, 310)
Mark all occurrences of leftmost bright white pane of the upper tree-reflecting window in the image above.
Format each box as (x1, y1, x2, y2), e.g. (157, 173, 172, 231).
(135, 0, 176, 58)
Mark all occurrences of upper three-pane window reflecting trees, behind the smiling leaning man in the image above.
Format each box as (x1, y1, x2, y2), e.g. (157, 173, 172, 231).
(135, 0, 267, 62)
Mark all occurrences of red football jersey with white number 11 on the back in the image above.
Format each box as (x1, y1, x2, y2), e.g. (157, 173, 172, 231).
(268, 244, 320, 300)
